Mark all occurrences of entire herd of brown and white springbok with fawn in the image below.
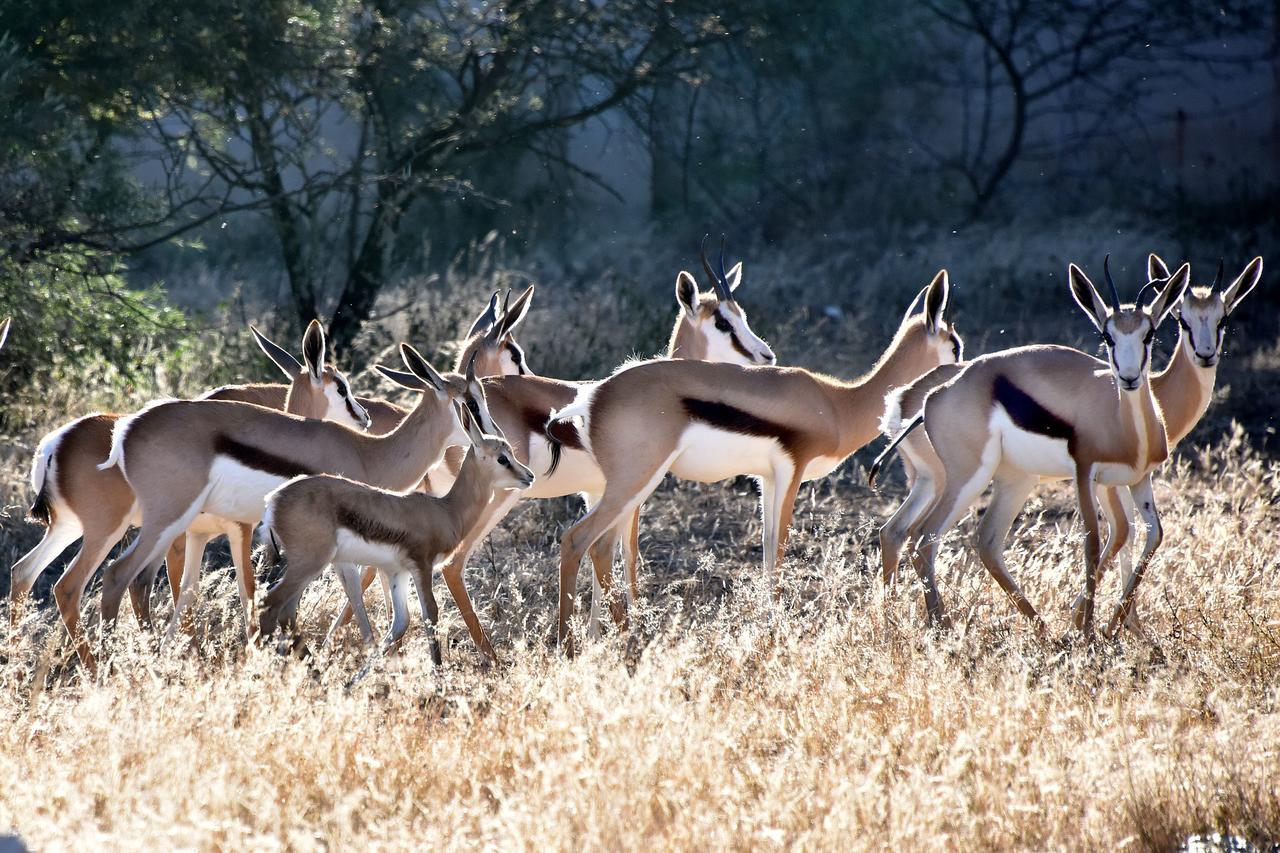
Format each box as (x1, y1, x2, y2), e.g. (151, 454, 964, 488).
(0, 246, 1262, 672)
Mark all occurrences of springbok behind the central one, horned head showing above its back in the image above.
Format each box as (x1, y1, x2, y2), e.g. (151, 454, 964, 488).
(330, 239, 774, 660)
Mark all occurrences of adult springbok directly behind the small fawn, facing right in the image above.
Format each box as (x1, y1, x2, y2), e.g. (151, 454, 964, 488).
(93, 343, 484, 655)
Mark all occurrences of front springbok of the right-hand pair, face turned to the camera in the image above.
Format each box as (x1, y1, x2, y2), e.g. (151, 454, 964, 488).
(882, 256, 1190, 638)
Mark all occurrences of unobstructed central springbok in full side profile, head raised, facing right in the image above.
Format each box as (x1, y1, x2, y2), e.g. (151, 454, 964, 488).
(550, 270, 963, 652)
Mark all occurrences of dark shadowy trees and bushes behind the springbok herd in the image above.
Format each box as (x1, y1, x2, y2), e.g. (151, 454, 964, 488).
(0, 0, 1280, 448)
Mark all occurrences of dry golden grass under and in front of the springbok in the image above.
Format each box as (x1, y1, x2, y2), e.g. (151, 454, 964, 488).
(0, 409, 1280, 849)
